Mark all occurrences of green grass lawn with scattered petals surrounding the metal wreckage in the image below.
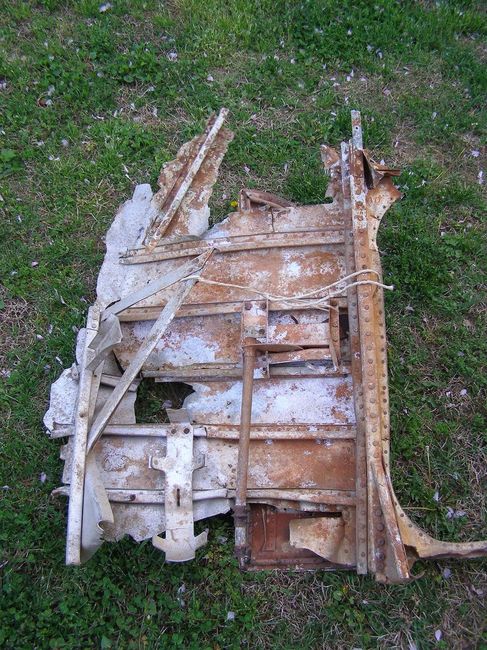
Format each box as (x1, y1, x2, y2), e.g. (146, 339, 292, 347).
(0, 0, 487, 649)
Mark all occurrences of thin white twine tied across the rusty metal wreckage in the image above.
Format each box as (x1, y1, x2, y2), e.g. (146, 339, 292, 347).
(181, 269, 394, 310)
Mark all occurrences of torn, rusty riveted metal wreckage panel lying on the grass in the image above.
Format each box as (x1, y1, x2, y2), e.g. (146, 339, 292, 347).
(44, 109, 487, 582)
